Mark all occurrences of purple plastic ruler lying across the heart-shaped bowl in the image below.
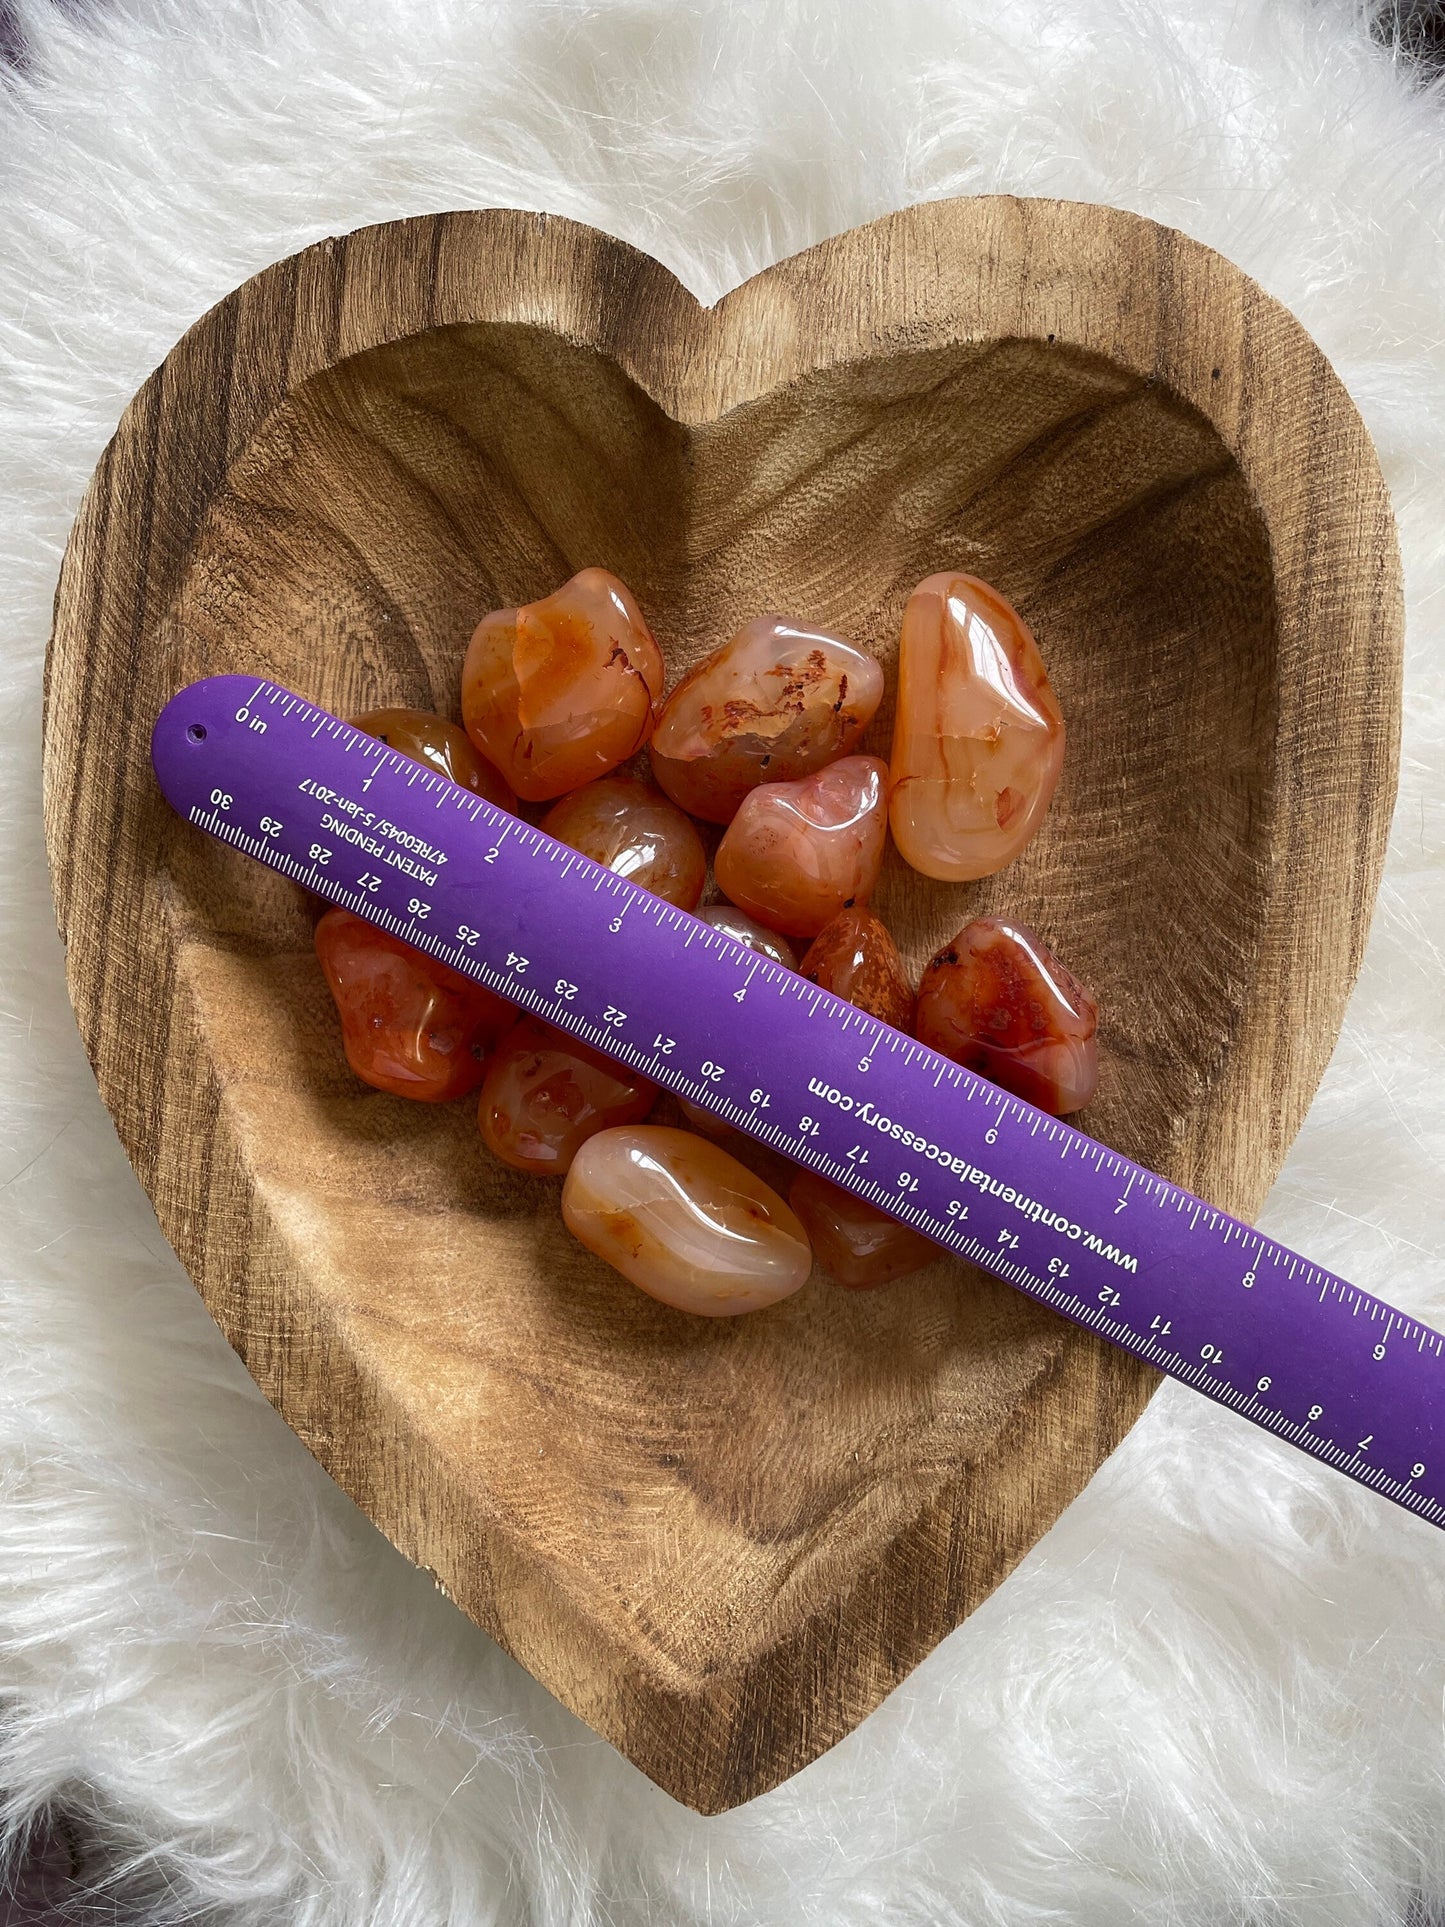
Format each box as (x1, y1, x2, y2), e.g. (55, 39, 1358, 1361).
(152, 676, 1445, 1526)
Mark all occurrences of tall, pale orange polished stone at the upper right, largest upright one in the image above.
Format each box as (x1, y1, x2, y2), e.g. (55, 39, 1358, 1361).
(888, 572, 1064, 883)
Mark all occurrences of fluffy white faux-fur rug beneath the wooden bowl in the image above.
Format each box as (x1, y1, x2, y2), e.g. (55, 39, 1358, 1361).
(0, 0, 1445, 1927)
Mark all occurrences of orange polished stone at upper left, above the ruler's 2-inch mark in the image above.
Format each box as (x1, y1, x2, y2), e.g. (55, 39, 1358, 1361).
(462, 568, 663, 804)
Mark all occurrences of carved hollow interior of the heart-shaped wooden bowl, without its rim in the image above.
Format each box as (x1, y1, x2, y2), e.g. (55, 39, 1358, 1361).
(150, 324, 1275, 1680)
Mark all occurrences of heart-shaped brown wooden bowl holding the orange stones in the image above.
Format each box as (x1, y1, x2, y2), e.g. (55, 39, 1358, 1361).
(44, 198, 1401, 1811)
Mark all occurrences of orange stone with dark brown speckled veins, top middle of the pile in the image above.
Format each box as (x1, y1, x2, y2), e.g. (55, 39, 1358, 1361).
(649, 615, 882, 823)
